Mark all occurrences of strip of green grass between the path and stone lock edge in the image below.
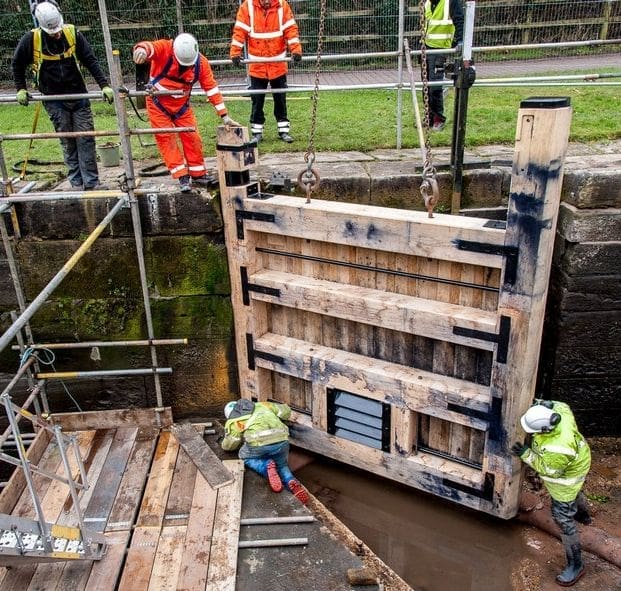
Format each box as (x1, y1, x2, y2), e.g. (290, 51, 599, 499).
(0, 69, 621, 175)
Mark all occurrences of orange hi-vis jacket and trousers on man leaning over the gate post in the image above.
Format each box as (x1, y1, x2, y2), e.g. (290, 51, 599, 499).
(134, 39, 227, 179)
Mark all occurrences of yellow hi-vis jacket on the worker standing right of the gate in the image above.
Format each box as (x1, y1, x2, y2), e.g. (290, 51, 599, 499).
(521, 402, 591, 502)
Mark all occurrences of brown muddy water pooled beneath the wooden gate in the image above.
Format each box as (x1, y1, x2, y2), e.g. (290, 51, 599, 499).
(296, 458, 523, 591)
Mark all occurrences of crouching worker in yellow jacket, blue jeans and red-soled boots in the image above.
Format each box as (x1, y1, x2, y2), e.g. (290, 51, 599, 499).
(221, 399, 308, 504)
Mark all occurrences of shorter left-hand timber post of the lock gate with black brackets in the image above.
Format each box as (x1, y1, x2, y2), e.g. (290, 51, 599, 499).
(216, 126, 271, 400)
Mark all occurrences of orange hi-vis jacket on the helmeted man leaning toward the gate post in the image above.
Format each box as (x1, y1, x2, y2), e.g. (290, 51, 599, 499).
(134, 39, 227, 117)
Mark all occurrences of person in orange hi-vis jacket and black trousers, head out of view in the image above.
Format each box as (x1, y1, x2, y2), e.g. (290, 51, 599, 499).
(229, 0, 302, 143)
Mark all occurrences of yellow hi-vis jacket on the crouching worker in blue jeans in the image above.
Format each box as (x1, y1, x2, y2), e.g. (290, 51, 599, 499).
(221, 402, 291, 451)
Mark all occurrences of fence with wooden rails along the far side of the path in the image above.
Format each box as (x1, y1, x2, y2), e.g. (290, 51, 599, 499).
(0, 0, 621, 87)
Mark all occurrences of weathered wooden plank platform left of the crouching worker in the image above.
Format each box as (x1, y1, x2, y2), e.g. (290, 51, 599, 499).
(0, 409, 243, 591)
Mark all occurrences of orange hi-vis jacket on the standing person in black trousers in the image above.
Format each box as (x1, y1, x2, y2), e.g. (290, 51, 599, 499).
(230, 0, 302, 80)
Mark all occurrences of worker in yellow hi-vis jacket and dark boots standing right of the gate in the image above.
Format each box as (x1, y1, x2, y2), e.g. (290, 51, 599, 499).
(511, 400, 591, 587)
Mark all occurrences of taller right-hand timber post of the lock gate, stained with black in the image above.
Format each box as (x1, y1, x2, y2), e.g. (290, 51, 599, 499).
(483, 97, 571, 517)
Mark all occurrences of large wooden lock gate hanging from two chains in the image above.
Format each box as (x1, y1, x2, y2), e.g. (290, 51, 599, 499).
(217, 98, 571, 518)
